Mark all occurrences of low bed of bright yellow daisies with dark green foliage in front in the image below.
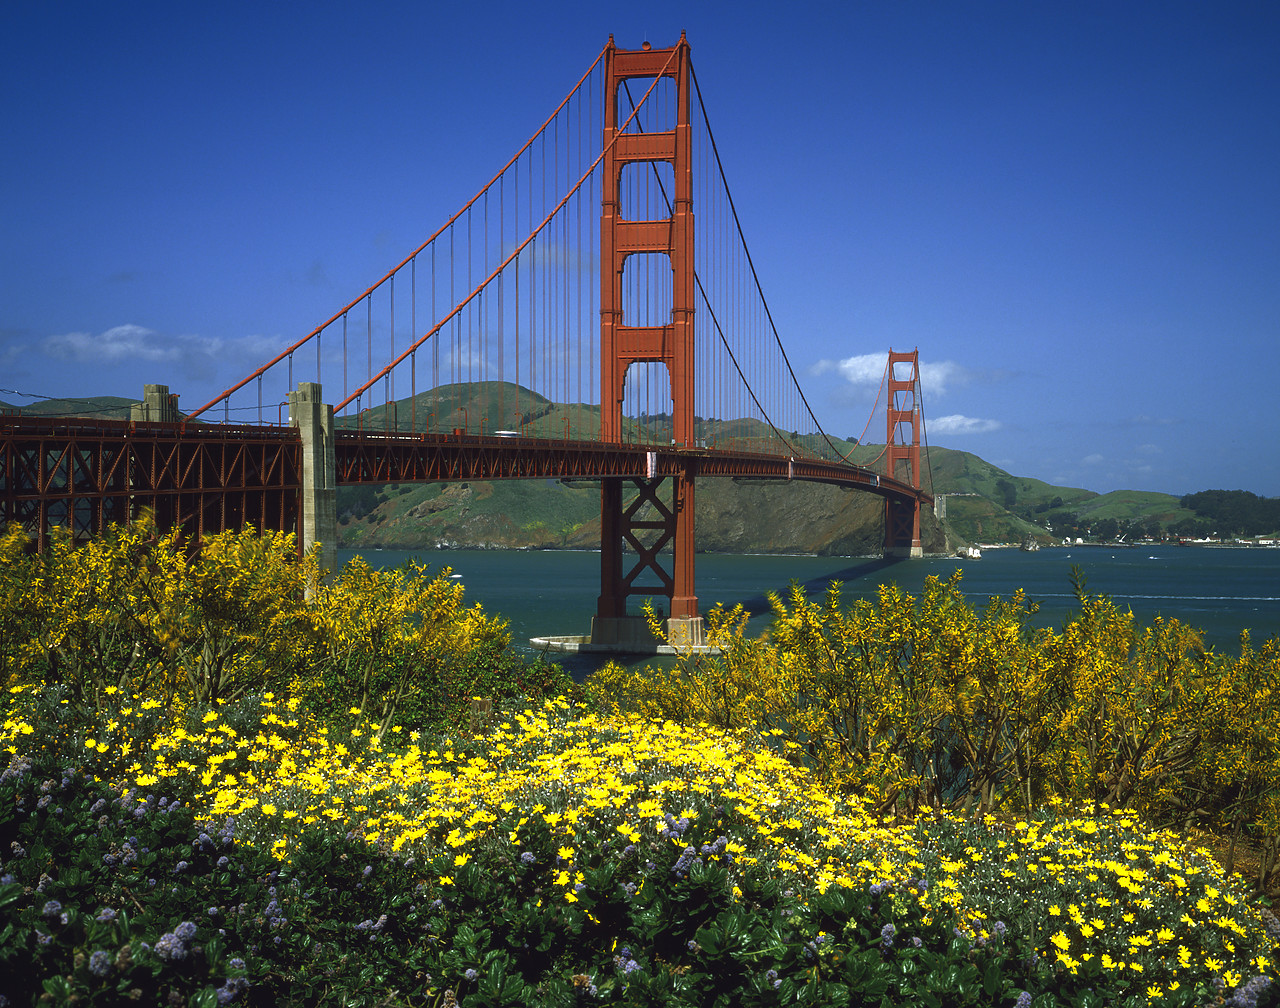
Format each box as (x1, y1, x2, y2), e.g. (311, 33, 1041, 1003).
(0, 693, 1275, 1008)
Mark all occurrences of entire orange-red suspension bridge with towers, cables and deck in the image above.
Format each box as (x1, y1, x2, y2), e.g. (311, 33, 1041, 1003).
(0, 35, 932, 650)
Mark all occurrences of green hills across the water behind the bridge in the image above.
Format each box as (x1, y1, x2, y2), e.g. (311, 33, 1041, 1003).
(10, 382, 1249, 555)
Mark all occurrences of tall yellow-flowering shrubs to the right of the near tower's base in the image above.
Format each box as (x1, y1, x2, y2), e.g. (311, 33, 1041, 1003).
(590, 572, 1280, 888)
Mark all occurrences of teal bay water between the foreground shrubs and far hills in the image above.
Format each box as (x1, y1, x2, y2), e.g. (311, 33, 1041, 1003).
(338, 546, 1280, 672)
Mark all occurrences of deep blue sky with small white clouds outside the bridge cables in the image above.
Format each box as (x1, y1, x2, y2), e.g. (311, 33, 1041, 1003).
(0, 0, 1280, 496)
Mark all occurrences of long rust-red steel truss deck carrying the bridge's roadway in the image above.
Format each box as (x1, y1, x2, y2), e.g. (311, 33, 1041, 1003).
(0, 416, 932, 547)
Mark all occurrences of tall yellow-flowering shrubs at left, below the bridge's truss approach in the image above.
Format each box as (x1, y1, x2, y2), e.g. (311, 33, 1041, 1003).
(0, 516, 571, 742)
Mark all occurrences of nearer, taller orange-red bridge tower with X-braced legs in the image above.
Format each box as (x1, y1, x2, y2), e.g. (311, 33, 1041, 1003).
(591, 33, 703, 645)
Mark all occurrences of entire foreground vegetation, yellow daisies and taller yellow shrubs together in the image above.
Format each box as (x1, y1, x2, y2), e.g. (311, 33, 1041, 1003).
(0, 523, 1280, 1008)
